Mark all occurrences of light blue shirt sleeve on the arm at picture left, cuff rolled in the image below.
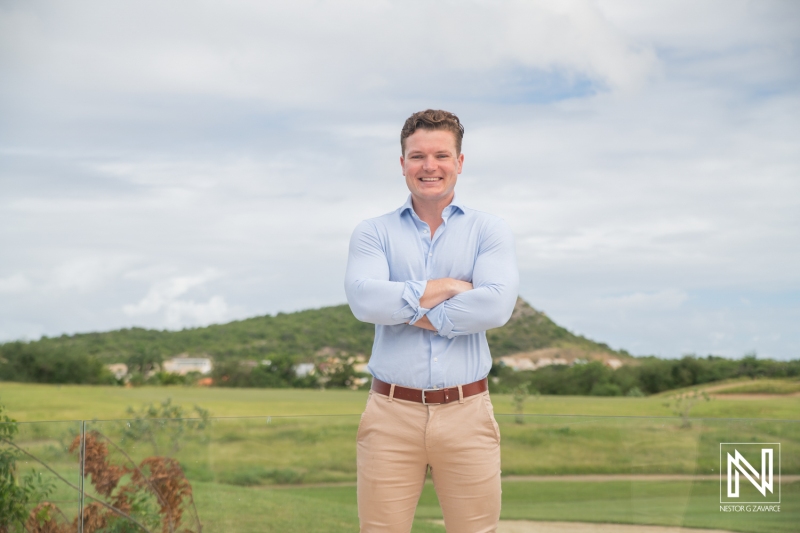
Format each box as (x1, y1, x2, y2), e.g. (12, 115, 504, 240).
(344, 221, 429, 326)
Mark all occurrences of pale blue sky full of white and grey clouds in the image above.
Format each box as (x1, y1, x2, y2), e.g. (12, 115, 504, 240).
(0, 0, 800, 359)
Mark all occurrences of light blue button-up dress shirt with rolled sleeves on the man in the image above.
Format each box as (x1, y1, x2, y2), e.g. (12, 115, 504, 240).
(345, 196, 519, 389)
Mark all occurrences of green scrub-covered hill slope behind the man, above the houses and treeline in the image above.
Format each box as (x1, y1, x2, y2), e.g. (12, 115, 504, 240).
(0, 299, 615, 363)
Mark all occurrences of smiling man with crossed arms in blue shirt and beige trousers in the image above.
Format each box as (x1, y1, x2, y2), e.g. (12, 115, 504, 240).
(345, 109, 519, 533)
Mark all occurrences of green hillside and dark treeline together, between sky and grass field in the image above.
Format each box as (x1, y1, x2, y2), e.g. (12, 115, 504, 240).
(0, 299, 800, 396)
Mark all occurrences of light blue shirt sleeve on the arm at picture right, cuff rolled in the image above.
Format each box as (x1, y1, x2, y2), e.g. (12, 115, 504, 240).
(427, 219, 519, 339)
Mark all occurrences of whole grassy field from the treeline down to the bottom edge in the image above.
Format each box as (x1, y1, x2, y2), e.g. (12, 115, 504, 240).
(0, 384, 800, 533)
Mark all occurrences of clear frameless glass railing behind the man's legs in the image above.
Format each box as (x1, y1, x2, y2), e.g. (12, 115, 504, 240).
(0, 415, 800, 533)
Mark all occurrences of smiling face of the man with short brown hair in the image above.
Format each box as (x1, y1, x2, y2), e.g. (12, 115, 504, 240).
(400, 129, 464, 202)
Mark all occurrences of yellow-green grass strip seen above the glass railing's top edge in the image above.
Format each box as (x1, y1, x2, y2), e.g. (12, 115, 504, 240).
(6, 383, 800, 421)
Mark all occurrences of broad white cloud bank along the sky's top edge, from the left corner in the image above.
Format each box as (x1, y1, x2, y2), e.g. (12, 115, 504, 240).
(0, 0, 657, 111)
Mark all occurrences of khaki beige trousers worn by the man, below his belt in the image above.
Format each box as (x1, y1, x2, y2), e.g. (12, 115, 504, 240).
(357, 391, 500, 533)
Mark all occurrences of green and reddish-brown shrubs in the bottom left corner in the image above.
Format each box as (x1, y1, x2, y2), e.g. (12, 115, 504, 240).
(0, 405, 202, 533)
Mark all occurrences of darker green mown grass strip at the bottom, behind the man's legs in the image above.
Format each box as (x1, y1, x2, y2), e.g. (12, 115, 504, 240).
(189, 481, 800, 533)
